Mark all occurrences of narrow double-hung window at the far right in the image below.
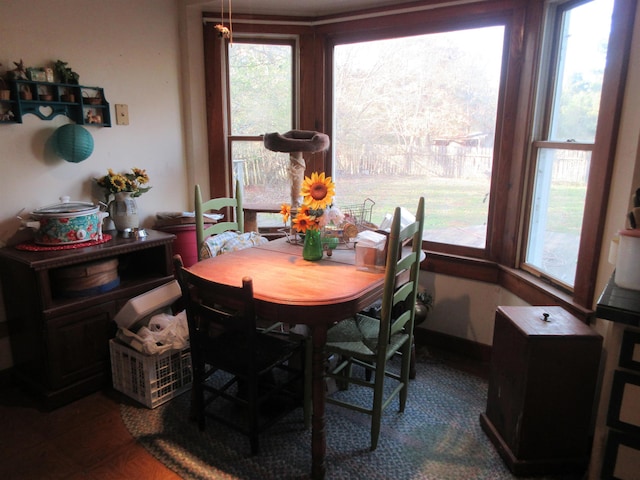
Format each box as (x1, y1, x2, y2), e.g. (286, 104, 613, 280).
(524, 0, 613, 289)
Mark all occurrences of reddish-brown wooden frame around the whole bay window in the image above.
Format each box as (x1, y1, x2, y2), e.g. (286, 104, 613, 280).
(205, 0, 636, 320)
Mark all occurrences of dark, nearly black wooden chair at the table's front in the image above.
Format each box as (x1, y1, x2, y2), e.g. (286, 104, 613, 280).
(173, 255, 308, 455)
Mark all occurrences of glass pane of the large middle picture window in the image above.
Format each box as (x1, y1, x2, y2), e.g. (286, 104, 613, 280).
(333, 26, 505, 249)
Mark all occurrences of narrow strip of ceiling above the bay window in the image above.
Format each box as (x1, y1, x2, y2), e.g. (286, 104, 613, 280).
(213, 0, 407, 17)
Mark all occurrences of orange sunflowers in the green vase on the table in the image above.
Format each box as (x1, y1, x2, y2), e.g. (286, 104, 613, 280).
(280, 172, 344, 234)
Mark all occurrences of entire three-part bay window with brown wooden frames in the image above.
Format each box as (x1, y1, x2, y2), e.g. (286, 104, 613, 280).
(205, 0, 637, 310)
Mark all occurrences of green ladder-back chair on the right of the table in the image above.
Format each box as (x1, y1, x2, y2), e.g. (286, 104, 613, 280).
(326, 197, 424, 450)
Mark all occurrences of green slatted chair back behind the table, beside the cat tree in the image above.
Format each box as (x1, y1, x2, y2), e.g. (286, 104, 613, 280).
(194, 181, 244, 260)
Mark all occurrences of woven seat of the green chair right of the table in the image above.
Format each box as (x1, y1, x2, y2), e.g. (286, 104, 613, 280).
(327, 315, 409, 362)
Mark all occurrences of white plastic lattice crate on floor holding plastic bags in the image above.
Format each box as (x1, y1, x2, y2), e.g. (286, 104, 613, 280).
(109, 339, 192, 408)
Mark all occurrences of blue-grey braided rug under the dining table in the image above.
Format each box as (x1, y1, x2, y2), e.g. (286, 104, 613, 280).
(121, 354, 582, 480)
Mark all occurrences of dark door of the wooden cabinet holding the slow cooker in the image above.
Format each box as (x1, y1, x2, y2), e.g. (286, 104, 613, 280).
(46, 302, 116, 389)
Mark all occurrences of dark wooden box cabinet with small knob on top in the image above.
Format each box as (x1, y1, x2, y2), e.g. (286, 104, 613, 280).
(480, 307, 602, 475)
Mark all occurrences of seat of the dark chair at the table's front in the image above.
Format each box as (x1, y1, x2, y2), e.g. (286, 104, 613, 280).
(204, 332, 303, 376)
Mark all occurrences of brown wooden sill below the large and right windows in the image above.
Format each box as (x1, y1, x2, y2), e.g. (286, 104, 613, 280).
(422, 251, 594, 323)
